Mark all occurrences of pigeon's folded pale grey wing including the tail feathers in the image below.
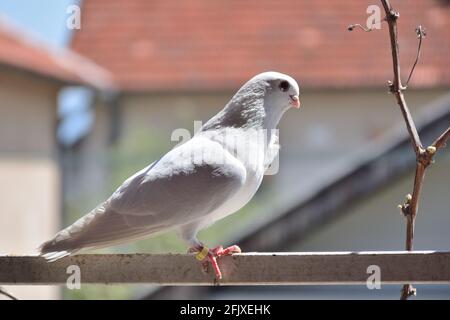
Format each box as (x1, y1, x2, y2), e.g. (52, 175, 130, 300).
(41, 136, 246, 259)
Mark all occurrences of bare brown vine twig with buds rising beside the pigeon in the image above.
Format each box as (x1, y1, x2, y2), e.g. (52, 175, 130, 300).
(349, 0, 450, 300)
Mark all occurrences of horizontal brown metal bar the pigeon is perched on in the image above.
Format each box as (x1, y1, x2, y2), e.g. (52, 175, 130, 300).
(0, 251, 450, 285)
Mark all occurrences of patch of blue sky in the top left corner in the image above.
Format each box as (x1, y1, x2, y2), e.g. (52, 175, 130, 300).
(0, 0, 80, 46)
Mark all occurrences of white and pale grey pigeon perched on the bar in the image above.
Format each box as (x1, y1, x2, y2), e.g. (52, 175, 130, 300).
(39, 71, 300, 279)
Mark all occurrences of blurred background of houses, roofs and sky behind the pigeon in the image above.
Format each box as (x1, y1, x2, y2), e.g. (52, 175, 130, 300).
(0, 0, 450, 299)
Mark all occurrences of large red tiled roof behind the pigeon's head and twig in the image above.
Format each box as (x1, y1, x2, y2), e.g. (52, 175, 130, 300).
(72, 0, 450, 91)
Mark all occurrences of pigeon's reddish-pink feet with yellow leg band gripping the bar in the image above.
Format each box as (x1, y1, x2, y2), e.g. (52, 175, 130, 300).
(188, 245, 242, 280)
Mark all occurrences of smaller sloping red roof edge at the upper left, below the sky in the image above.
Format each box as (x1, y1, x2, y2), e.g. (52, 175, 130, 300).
(0, 19, 113, 89)
